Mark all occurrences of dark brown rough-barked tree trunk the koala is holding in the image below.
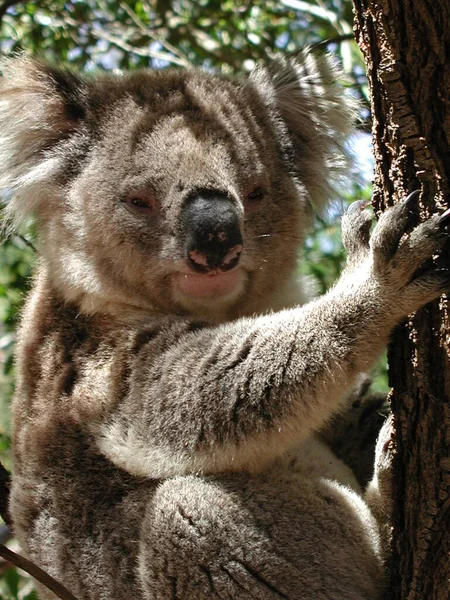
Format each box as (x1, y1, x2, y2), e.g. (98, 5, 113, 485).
(354, 0, 450, 600)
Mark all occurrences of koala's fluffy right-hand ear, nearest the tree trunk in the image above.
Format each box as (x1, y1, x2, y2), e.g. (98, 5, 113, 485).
(250, 50, 358, 211)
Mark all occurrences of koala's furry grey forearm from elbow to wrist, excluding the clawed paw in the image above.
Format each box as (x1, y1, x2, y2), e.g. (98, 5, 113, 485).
(101, 294, 386, 477)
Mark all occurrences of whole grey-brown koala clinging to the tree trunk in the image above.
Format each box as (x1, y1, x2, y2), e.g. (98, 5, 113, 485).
(0, 52, 449, 600)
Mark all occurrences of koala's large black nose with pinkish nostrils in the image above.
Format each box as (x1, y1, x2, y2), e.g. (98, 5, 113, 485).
(181, 190, 242, 273)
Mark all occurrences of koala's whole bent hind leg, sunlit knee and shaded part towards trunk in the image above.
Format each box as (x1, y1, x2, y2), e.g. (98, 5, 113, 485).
(139, 476, 383, 600)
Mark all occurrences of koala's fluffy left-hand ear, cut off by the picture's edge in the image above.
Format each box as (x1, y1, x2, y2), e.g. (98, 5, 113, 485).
(0, 55, 86, 227)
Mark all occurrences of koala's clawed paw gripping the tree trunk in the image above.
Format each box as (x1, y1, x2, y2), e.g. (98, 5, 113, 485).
(342, 191, 450, 316)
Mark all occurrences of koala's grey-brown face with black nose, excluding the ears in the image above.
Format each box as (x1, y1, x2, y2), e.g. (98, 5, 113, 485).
(62, 72, 306, 314)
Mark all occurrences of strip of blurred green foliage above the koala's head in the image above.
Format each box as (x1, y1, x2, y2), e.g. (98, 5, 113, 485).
(2, 0, 363, 73)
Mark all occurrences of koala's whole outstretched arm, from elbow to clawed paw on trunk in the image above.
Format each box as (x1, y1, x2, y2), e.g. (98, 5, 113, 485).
(93, 198, 448, 477)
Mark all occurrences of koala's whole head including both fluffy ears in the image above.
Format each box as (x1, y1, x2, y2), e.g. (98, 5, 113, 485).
(0, 54, 353, 317)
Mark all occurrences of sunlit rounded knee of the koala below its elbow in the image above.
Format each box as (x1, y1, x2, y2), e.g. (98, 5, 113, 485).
(139, 477, 287, 600)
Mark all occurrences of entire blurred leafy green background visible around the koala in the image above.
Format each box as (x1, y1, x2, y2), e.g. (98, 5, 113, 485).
(0, 0, 386, 600)
